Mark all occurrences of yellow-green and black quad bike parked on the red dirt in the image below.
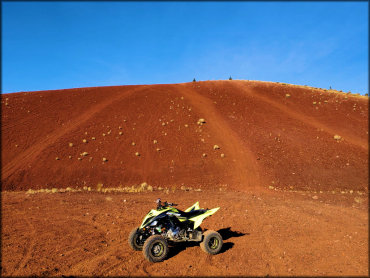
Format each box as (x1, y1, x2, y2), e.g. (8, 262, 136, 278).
(128, 199, 223, 263)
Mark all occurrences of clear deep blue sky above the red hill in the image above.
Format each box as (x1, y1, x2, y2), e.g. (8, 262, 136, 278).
(2, 1, 369, 94)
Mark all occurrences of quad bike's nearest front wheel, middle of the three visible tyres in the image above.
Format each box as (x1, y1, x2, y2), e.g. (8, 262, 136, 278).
(143, 235, 168, 263)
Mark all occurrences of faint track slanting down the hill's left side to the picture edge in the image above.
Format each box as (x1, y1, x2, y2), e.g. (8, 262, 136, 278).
(2, 85, 147, 180)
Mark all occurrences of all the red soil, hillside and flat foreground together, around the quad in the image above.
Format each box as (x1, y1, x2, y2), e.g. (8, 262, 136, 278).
(0, 81, 369, 276)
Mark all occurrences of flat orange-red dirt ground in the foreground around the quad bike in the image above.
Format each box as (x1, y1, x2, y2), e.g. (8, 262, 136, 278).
(1, 191, 368, 276)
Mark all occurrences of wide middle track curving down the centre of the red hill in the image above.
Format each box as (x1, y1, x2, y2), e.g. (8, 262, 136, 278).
(172, 84, 261, 189)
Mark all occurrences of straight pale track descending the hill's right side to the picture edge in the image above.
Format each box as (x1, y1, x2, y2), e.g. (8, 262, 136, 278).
(231, 82, 369, 150)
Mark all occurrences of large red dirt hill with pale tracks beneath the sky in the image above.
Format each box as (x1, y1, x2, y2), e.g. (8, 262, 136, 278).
(1, 80, 368, 191)
